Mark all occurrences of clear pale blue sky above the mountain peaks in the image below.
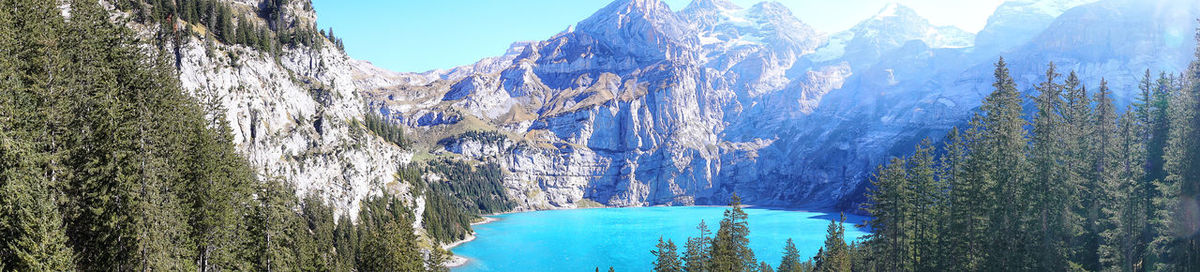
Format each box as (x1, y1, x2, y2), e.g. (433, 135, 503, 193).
(312, 0, 1003, 72)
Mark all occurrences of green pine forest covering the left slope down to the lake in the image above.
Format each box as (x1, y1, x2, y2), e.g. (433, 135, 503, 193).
(0, 0, 448, 271)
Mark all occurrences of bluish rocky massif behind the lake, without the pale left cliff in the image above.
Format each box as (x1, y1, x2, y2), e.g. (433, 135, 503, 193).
(354, 0, 1200, 208)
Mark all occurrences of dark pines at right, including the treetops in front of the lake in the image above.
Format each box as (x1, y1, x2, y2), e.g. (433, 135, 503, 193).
(652, 26, 1200, 272)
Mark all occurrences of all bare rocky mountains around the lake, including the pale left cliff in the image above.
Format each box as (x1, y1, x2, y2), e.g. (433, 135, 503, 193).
(150, 0, 1200, 214)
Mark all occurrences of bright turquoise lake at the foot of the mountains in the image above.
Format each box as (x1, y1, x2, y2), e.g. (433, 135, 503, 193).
(452, 206, 868, 272)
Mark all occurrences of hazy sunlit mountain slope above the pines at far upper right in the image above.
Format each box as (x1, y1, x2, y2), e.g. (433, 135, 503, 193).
(1012, 0, 1200, 104)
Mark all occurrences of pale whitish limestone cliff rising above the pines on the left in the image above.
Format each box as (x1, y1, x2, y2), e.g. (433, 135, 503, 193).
(149, 0, 424, 218)
